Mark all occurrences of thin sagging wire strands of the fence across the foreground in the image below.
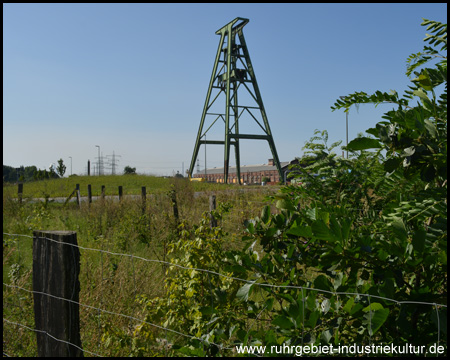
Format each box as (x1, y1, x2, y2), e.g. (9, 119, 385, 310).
(3, 233, 447, 356)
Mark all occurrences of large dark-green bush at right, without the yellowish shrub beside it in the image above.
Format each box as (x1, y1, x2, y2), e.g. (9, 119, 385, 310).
(227, 20, 447, 352)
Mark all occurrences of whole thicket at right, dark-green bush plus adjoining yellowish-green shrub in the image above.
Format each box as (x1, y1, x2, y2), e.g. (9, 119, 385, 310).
(137, 20, 447, 355)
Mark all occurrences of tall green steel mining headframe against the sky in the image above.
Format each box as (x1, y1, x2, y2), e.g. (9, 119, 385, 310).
(189, 17, 283, 184)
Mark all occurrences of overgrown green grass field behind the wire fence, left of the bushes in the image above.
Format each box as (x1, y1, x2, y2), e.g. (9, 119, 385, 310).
(3, 175, 277, 356)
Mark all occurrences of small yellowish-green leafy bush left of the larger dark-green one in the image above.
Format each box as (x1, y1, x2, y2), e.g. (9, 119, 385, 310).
(135, 204, 248, 356)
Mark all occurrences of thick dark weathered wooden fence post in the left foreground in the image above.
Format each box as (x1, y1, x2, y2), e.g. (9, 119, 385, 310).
(33, 231, 83, 357)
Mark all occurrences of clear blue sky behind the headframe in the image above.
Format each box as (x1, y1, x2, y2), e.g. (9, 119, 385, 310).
(3, 3, 447, 175)
